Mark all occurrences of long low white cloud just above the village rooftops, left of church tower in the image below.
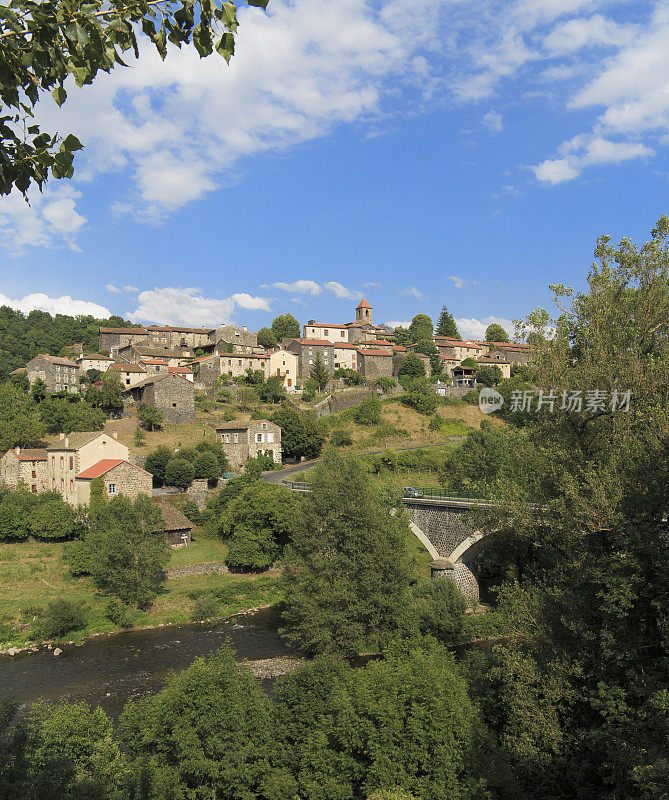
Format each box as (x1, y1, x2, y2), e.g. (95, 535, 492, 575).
(127, 287, 270, 326)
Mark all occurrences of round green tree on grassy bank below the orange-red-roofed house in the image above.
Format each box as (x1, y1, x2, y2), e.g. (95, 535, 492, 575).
(68, 495, 170, 607)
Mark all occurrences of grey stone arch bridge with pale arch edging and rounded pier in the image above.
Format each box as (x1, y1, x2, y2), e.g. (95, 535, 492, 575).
(402, 497, 491, 602)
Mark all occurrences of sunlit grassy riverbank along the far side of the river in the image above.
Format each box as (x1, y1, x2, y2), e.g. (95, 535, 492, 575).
(0, 534, 283, 653)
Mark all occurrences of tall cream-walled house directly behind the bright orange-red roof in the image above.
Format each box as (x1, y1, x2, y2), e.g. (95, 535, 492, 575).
(46, 431, 129, 505)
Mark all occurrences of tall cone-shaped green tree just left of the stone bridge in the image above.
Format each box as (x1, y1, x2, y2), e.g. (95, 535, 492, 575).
(284, 455, 410, 655)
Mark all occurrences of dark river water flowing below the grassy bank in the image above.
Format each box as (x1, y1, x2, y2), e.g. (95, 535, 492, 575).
(0, 609, 289, 718)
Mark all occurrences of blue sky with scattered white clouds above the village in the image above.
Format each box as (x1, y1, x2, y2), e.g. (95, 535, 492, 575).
(0, 0, 669, 338)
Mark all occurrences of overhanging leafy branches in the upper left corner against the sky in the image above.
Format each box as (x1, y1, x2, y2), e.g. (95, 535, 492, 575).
(0, 0, 267, 195)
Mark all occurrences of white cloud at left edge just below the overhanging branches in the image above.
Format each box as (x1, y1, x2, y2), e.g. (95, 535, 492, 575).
(0, 182, 86, 255)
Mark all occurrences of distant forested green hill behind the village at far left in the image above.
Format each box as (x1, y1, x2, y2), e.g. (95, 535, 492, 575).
(0, 306, 136, 381)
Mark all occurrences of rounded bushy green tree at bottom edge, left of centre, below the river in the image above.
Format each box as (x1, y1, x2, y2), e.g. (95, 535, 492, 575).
(119, 647, 274, 800)
